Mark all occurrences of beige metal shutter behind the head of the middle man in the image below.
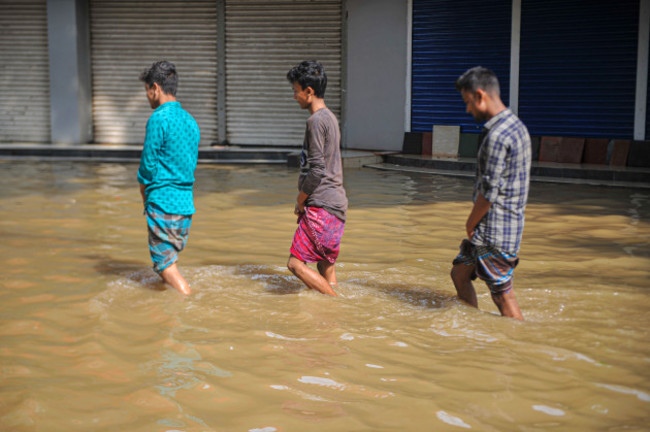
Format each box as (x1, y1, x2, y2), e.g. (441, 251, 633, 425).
(226, 0, 341, 145)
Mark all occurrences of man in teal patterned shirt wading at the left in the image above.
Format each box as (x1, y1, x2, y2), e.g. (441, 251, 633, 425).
(138, 61, 200, 295)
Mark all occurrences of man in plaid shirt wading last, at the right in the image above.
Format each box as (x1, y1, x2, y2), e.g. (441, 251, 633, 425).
(451, 66, 531, 320)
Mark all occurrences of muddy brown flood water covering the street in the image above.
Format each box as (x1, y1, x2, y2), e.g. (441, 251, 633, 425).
(0, 160, 650, 432)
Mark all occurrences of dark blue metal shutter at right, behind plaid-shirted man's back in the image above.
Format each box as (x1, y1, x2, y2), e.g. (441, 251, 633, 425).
(519, 0, 639, 138)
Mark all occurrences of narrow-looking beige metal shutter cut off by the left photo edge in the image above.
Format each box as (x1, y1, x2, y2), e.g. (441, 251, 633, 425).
(0, 0, 50, 143)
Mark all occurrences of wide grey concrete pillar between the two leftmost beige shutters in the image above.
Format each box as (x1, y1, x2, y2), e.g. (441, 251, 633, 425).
(47, 0, 93, 144)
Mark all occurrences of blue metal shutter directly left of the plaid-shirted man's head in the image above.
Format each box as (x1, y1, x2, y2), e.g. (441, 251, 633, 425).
(411, 0, 512, 132)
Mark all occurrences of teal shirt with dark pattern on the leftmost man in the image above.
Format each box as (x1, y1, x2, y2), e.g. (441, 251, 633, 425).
(138, 102, 200, 215)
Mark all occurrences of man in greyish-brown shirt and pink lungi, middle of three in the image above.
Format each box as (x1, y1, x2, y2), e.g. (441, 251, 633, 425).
(287, 60, 348, 295)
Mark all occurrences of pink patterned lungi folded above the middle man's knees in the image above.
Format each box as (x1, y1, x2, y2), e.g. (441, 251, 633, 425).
(291, 207, 345, 264)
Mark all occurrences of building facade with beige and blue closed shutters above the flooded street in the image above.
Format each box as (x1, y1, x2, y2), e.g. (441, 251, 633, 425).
(0, 0, 650, 150)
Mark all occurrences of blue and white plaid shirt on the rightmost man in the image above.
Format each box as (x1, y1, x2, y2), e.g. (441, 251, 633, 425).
(472, 109, 531, 254)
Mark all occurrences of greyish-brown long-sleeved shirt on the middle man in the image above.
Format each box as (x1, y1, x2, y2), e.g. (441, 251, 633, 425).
(298, 108, 348, 221)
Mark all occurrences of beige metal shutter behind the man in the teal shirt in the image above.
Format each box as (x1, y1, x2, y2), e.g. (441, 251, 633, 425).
(90, 0, 217, 145)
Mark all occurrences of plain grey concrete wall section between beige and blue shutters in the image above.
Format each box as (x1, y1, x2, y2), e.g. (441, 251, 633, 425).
(343, 0, 408, 150)
